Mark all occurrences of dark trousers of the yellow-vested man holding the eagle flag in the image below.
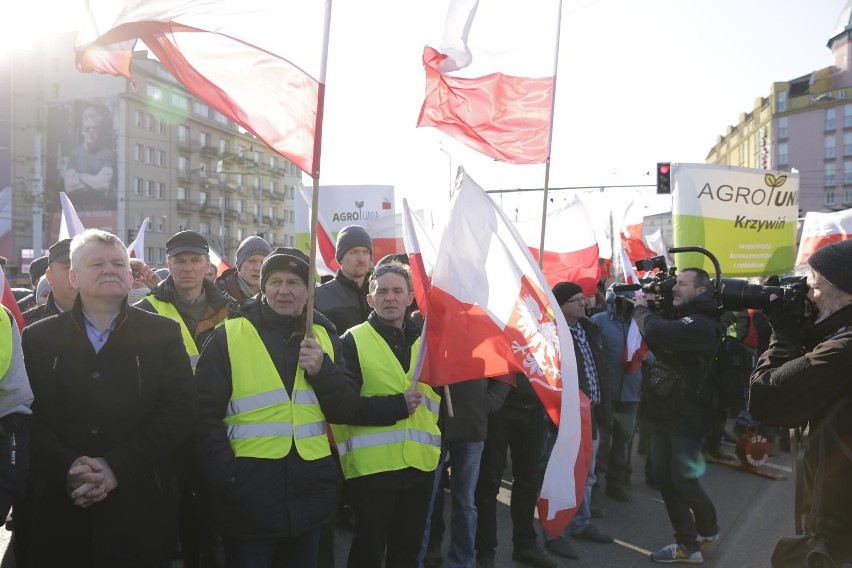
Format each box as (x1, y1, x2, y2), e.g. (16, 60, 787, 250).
(347, 472, 435, 568)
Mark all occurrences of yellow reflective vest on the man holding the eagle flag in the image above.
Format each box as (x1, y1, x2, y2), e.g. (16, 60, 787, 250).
(331, 322, 441, 479)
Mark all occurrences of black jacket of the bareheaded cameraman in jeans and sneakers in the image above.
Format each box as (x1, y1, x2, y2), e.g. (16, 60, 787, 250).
(633, 292, 722, 437)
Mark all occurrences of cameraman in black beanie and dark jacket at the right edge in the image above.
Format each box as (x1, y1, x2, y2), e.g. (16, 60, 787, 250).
(749, 240, 852, 566)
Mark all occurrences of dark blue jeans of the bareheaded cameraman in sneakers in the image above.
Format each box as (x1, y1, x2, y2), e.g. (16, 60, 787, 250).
(650, 429, 719, 547)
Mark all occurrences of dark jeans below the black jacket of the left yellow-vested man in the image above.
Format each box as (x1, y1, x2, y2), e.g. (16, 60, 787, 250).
(223, 528, 320, 568)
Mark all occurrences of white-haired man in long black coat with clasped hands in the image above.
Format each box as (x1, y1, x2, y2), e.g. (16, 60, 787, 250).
(23, 229, 195, 567)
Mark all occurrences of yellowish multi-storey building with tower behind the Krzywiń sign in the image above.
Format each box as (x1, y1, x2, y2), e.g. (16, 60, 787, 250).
(707, 1, 852, 213)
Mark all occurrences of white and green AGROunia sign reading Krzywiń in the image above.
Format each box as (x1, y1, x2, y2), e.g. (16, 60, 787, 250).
(672, 164, 799, 277)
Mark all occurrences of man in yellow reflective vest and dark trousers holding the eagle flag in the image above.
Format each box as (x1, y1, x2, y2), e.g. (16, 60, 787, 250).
(332, 263, 441, 568)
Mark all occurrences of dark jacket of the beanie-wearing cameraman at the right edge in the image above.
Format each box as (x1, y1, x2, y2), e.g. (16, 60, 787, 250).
(749, 306, 852, 564)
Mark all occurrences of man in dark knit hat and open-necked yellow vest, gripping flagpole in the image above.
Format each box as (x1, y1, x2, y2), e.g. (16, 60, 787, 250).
(196, 249, 358, 568)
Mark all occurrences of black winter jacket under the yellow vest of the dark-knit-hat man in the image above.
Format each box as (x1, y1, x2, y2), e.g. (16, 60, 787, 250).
(196, 296, 359, 538)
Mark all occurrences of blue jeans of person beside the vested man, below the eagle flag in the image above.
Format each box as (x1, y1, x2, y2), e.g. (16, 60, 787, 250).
(418, 442, 485, 568)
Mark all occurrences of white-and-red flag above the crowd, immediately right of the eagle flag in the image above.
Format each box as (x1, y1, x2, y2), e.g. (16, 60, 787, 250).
(515, 196, 602, 295)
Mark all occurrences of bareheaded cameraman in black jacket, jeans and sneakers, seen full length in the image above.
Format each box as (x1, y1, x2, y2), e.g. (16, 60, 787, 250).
(631, 268, 721, 564)
